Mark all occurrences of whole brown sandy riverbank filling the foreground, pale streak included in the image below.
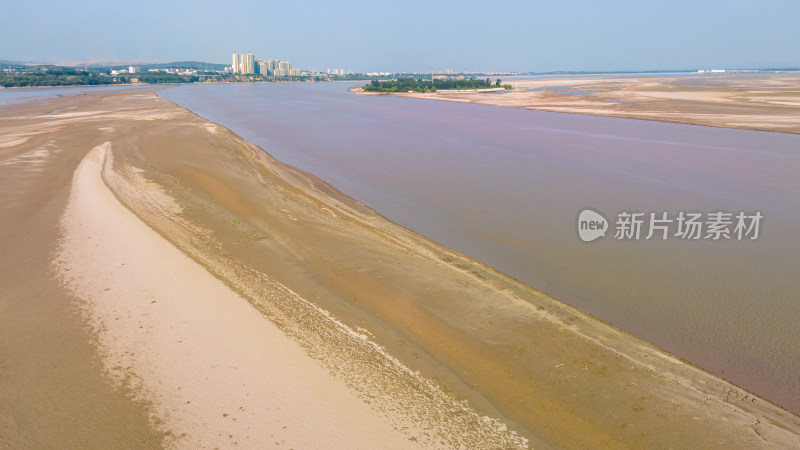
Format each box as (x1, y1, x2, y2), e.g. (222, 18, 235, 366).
(0, 88, 800, 448)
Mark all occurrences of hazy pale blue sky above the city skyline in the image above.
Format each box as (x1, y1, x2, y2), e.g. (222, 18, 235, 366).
(0, 0, 800, 72)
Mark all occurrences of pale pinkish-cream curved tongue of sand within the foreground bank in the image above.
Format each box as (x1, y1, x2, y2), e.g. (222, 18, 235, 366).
(60, 144, 413, 448)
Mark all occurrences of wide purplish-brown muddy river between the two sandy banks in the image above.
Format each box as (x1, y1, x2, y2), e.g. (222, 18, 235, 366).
(159, 83, 800, 413)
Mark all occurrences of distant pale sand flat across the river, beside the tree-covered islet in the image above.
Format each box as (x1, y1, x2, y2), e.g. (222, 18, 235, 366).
(357, 72, 800, 133)
